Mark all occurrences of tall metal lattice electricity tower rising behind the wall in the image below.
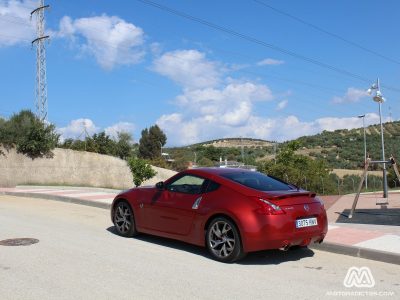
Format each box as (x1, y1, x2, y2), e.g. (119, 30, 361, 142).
(31, 0, 50, 121)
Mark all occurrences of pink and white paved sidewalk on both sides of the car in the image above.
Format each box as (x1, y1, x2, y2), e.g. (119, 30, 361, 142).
(0, 186, 400, 265)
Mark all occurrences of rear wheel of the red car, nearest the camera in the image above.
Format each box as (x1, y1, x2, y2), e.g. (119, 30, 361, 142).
(206, 217, 245, 263)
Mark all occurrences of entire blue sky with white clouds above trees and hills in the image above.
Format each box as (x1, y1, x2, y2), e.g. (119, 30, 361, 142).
(0, 0, 400, 146)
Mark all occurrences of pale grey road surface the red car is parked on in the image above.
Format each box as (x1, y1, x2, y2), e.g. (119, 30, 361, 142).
(0, 196, 400, 299)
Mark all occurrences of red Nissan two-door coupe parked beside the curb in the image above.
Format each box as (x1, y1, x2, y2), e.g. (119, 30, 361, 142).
(111, 168, 327, 262)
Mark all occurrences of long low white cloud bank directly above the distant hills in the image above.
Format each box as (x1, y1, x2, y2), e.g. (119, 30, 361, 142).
(157, 113, 379, 145)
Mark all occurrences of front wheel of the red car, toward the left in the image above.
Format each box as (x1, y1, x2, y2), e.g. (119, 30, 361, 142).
(113, 201, 137, 237)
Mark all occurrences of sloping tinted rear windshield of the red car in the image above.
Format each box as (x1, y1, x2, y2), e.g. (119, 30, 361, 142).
(221, 172, 293, 191)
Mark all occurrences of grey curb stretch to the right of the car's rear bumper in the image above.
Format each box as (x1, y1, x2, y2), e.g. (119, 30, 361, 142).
(309, 242, 400, 265)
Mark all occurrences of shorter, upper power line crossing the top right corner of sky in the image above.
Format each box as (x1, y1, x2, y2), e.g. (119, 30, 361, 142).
(253, 0, 400, 65)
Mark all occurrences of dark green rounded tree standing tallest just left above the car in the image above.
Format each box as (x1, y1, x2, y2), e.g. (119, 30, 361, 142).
(139, 125, 167, 160)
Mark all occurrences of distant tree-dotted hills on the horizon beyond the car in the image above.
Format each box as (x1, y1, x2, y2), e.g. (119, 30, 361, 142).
(168, 121, 400, 169)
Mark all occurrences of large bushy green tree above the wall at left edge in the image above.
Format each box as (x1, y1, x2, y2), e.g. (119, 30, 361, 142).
(0, 110, 59, 159)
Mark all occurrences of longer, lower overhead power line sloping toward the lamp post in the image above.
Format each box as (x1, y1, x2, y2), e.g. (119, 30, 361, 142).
(136, 0, 400, 92)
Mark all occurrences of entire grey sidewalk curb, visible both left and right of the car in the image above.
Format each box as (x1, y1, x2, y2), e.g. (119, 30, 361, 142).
(0, 192, 400, 265)
